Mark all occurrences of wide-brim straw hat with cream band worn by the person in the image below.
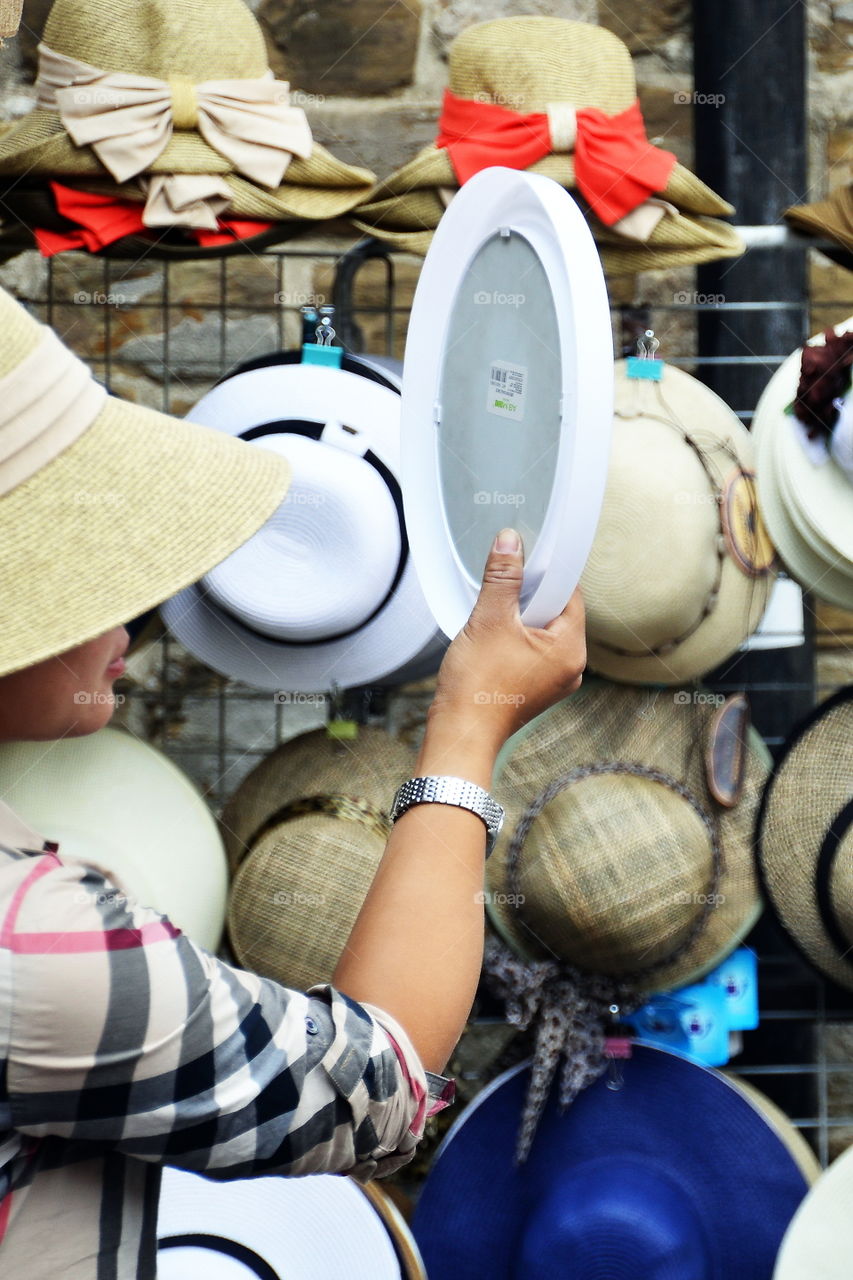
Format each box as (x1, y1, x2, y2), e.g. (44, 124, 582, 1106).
(0, 291, 289, 675)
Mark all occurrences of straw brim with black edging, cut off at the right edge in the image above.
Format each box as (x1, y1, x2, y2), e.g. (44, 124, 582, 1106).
(756, 685, 853, 991)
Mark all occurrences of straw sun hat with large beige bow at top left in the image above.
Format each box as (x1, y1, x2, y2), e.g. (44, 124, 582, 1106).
(0, 0, 373, 241)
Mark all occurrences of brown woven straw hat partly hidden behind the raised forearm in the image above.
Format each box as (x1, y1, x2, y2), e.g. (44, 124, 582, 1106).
(222, 727, 415, 991)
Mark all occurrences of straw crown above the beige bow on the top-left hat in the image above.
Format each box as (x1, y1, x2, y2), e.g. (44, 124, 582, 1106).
(44, 0, 263, 83)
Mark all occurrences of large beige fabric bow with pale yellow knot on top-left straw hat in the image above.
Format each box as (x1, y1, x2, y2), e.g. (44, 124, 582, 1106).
(36, 44, 313, 227)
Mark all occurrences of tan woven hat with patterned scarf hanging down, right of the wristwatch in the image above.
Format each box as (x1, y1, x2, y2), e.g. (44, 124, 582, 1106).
(485, 680, 770, 1156)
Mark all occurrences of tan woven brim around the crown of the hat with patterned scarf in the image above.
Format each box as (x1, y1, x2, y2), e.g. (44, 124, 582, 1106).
(487, 680, 771, 991)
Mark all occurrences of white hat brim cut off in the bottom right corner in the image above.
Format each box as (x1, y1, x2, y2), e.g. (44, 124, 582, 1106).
(774, 1147, 853, 1280)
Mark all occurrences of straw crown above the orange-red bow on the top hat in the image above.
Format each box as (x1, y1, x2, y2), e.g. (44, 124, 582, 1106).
(450, 17, 637, 115)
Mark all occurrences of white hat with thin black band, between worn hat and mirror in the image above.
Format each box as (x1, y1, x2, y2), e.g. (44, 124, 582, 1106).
(161, 355, 444, 690)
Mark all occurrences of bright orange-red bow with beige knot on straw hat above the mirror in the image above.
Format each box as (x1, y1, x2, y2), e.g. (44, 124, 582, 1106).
(435, 90, 676, 227)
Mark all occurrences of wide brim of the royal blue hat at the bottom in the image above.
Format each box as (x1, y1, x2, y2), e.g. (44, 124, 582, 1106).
(412, 1044, 808, 1280)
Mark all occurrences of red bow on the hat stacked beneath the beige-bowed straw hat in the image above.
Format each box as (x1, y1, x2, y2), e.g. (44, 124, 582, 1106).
(35, 182, 273, 257)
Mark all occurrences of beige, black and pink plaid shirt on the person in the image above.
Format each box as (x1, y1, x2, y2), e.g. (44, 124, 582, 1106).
(0, 804, 452, 1280)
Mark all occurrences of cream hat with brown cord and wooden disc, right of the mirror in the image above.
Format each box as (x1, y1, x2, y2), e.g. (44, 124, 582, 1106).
(581, 361, 776, 685)
